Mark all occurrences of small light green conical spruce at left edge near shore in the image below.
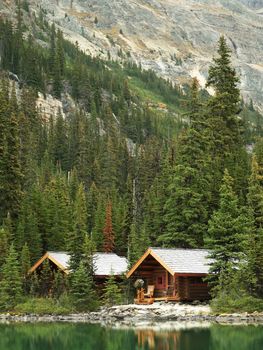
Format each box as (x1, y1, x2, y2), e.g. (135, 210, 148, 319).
(0, 244, 22, 311)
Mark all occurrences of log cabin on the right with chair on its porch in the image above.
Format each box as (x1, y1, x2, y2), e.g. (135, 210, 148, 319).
(126, 248, 210, 303)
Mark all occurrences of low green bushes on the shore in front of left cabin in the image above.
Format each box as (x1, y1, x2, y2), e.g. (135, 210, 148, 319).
(14, 295, 75, 315)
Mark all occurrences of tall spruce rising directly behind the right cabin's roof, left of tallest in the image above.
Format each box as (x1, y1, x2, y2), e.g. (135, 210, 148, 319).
(162, 79, 211, 248)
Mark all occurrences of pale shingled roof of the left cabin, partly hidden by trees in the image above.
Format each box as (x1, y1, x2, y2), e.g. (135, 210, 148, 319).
(29, 251, 128, 276)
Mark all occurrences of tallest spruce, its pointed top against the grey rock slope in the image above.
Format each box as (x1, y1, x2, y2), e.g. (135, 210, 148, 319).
(206, 36, 249, 208)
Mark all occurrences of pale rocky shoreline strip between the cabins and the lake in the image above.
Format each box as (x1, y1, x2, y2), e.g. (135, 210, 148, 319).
(0, 303, 263, 327)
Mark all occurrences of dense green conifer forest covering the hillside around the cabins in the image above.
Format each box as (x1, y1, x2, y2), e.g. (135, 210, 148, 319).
(0, 6, 263, 311)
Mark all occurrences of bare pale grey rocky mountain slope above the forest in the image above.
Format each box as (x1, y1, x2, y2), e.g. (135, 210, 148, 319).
(1, 0, 263, 110)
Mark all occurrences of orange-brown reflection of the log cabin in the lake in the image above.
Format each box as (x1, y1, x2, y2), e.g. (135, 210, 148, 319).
(136, 329, 180, 350)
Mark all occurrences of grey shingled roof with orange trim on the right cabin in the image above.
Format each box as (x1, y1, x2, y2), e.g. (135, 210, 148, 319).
(127, 248, 211, 277)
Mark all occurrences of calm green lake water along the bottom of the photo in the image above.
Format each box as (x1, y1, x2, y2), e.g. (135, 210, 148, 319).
(0, 323, 263, 350)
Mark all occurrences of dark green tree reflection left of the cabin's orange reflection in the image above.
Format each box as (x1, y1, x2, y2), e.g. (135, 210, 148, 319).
(0, 323, 137, 350)
